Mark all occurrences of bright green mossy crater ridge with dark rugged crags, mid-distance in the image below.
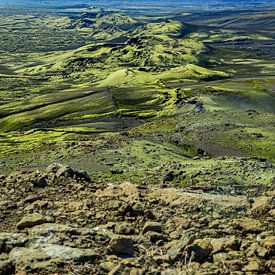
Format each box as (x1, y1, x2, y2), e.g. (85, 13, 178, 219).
(19, 17, 227, 84)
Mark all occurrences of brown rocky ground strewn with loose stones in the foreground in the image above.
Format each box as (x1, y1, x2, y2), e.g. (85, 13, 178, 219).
(0, 164, 275, 275)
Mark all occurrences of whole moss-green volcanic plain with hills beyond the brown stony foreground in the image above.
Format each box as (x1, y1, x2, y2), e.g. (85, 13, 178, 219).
(0, 3, 275, 186)
